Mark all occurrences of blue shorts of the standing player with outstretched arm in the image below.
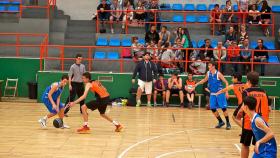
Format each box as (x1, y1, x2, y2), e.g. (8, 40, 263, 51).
(210, 93, 227, 110)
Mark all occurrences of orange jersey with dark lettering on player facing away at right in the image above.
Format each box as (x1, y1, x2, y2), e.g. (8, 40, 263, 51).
(243, 87, 269, 130)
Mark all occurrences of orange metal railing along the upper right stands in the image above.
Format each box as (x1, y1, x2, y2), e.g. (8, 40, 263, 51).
(96, 10, 275, 36)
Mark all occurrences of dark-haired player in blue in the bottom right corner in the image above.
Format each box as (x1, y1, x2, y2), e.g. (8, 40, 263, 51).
(242, 96, 277, 158)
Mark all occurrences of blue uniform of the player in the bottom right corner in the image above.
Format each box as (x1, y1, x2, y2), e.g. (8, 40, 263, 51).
(251, 114, 277, 158)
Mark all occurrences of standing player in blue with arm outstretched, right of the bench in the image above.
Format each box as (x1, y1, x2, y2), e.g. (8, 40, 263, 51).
(193, 61, 231, 130)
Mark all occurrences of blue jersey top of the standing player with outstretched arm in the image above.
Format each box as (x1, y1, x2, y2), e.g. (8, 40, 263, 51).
(207, 71, 224, 94)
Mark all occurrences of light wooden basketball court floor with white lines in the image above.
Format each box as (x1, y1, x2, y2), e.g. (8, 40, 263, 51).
(0, 102, 280, 158)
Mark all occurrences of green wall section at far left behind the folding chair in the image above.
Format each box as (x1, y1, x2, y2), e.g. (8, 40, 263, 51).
(0, 58, 40, 97)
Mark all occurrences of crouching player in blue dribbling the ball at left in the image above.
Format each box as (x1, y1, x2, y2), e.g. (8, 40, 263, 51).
(38, 75, 69, 128)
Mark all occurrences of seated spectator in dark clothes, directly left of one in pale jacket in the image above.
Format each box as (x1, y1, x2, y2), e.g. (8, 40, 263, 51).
(198, 39, 214, 61)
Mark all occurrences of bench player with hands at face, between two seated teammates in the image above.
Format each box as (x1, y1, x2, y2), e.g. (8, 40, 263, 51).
(166, 73, 184, 108)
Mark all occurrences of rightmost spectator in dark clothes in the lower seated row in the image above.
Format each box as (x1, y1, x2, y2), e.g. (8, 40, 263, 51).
(254, 39, 268, 76)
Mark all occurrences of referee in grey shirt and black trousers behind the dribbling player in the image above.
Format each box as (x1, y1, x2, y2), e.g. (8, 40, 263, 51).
(64, 54, 86, 117)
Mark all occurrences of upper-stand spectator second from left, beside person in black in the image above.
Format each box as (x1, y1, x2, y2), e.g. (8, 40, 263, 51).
(110, 0, 123, 33)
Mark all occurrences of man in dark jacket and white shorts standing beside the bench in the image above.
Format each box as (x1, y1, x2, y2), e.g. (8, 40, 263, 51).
(132, 53, 157, 107)
